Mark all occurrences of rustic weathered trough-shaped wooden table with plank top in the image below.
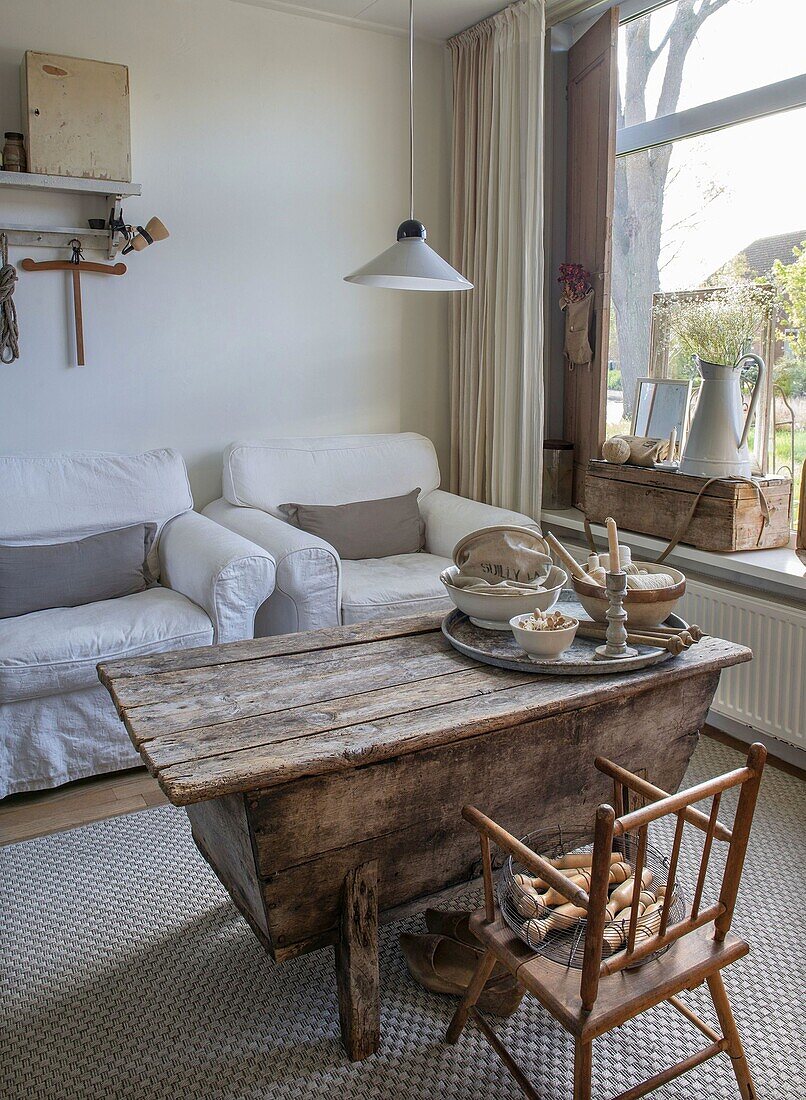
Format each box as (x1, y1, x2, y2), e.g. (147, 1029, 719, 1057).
(99, 614, 751, 1059)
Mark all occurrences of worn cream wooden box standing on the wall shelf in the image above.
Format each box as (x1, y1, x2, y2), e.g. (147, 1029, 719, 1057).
(21, 50, 132, 182)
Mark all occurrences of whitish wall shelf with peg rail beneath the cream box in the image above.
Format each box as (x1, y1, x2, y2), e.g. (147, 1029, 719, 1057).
(0, 171, 142, 260)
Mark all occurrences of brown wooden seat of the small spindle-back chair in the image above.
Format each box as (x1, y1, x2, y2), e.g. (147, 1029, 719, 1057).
(471, 910, 750, 1042)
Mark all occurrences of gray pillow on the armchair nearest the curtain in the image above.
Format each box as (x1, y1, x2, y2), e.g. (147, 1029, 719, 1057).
(279, 488, 426, 561)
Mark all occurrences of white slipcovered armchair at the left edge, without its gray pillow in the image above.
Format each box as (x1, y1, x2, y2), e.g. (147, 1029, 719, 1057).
(0, 450, 275, 798)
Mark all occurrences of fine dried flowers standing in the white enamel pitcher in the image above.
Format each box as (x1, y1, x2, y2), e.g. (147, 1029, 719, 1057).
(654, 283, 775, 366)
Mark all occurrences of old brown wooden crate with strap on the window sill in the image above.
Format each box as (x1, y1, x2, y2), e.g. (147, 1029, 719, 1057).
(585, 459, 792, 551)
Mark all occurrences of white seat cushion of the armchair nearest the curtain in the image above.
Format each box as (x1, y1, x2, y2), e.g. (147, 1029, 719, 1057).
(342, 553, 453, 624)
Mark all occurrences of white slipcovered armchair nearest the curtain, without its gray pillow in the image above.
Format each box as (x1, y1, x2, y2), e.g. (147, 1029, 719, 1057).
(205, 432, 536, 637)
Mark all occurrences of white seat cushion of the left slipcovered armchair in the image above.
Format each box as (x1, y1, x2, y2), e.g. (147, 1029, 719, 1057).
(0, 586, 212, 703)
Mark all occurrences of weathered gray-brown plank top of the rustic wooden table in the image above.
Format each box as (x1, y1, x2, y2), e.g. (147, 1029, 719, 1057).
(98, 613, 752, 805)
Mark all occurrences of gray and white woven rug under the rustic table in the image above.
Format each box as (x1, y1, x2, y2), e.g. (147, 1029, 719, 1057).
(0, 738, 806, 1100)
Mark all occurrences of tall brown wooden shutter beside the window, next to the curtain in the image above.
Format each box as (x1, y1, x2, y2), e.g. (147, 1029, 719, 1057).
(563, 8, 618, 508)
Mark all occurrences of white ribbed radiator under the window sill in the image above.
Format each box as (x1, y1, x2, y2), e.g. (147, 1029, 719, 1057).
(677, 578, 806, 749)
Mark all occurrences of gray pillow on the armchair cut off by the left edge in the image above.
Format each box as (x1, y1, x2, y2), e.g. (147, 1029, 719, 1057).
(0, 524, 156, 618)
